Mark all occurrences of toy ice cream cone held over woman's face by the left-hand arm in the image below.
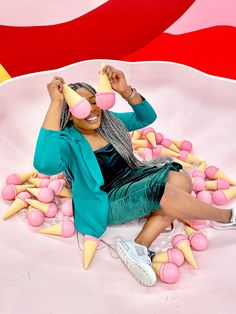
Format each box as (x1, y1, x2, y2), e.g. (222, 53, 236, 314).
(63, 84, 91, 119)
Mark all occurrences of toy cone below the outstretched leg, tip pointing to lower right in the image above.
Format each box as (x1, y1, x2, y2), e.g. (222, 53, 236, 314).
(173, 234, 197, 268)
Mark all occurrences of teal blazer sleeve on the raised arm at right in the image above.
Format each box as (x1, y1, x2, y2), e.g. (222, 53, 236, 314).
(110, 99, 157, 131)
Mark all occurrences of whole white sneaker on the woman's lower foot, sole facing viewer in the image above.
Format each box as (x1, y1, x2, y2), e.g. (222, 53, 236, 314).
(116, 240, 156, 287)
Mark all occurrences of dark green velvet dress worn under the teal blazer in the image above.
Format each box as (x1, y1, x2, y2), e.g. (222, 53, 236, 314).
(94, 143, 182, 225)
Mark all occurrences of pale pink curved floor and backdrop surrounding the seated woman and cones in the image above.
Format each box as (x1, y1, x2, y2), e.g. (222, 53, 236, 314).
(0, 61, 236, 314)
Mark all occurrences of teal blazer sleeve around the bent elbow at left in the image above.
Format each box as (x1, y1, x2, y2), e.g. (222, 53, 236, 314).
(34, 128, 70, 175)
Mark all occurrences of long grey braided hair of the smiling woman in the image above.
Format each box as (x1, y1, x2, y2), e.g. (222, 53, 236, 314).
(60, 83, 173, 186)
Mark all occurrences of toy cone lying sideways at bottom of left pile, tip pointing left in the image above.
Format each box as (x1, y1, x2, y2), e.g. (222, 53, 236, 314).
(39, 220, 75, 238)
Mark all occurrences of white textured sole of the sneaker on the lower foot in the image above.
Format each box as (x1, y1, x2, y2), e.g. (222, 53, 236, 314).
(116, 242, 156, 287)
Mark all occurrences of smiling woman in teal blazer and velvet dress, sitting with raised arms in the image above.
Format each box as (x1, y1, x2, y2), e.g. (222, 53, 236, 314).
(34, 65, 236, 286)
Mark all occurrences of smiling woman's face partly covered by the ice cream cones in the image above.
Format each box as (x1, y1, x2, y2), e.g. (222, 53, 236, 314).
(70, 87, 101, 134)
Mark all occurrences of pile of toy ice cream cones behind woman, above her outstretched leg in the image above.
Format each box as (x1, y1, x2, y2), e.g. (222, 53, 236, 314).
(130, 127, 236, 205)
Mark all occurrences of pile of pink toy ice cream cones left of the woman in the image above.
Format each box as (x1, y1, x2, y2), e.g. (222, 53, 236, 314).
(1, 170, 75, 237)
